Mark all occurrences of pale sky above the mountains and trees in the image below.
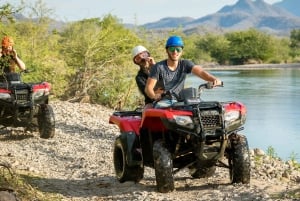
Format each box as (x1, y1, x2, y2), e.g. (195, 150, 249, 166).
(9, 0, 281, 25)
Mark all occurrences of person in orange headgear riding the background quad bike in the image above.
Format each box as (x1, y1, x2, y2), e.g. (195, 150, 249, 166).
(0, 36, 26, 73)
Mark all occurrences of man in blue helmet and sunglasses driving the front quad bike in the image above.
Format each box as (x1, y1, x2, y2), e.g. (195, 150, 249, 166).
(145, 36, 222, 108)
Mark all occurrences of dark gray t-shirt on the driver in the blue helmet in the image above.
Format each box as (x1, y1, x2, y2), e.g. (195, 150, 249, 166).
(149, 59, 195, 98)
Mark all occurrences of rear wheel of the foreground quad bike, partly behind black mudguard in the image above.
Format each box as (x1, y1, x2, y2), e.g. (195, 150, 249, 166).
(113, 137, 144, 183)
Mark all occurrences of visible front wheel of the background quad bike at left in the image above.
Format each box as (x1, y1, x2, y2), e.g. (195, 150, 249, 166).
(37, 104, 55, 139)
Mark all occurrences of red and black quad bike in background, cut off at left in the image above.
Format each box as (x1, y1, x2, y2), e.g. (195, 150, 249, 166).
(0, 71, 55, 139)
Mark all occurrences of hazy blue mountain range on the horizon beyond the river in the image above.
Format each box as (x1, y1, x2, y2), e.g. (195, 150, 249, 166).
(143, 0, 300, 35)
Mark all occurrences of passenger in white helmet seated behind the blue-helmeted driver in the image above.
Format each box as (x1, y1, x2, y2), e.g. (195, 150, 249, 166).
(132, 45, 163, 108)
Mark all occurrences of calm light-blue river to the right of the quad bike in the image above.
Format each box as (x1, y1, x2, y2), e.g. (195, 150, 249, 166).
(186, 69, 300, 162)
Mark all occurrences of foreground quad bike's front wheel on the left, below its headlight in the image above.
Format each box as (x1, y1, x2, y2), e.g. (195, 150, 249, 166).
(153, 140, 174, 193)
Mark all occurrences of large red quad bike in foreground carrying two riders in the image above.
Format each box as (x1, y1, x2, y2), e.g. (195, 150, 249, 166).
(109, 83, 250, 193)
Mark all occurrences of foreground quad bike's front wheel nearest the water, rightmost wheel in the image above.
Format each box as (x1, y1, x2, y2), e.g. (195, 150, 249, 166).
(228, 134, 250, 184)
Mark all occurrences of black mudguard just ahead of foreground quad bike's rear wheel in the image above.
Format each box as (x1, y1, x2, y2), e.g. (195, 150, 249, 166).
(120, 132, 143, 166)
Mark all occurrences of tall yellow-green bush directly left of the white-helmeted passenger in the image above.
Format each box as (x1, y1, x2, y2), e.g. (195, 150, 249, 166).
(61, 15, 138, 107)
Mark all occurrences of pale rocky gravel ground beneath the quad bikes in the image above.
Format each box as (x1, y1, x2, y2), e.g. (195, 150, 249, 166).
(0, 101, 300, 201)
